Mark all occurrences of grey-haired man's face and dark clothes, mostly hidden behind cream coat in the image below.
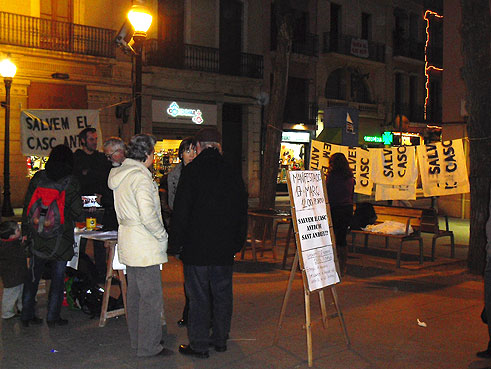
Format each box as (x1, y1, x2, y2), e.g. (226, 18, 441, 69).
(101, 137, 126, 231)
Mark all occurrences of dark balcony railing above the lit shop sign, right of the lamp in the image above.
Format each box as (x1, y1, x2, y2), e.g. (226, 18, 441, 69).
(145, 39, 263, 78)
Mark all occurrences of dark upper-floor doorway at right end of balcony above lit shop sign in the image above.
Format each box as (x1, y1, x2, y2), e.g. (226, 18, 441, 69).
(220, 0, 242, 75)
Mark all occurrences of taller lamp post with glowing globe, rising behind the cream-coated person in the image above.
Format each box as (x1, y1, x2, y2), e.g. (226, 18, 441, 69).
(128, 5, 152, 134)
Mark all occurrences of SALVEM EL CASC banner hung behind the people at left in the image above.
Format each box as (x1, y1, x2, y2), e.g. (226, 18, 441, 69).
(20, 109, 102, 156)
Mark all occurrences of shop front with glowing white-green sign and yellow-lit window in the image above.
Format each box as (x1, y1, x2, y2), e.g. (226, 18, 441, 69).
(152, 100, 218, 182)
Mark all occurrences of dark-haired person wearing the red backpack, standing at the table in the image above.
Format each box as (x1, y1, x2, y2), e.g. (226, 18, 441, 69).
(21, 145, 83, 327)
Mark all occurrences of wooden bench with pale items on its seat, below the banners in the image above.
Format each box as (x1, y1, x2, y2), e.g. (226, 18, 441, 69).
(351, 205, 423, 268)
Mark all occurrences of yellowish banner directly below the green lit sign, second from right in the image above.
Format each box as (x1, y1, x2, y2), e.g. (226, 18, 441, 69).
(370, 146, 418, 186)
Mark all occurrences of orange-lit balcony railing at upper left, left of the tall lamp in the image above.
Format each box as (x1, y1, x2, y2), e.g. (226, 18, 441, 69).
(0, 12, 116, 58)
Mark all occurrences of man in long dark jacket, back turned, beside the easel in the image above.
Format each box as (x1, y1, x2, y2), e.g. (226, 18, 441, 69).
(169, 128, 247, 358)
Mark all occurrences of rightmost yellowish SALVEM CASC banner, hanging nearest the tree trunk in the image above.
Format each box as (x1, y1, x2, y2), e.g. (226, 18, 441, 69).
(417, 139, 470, 196)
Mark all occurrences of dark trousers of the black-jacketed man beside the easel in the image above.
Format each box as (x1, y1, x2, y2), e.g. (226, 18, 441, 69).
(184, 264, 233, 351)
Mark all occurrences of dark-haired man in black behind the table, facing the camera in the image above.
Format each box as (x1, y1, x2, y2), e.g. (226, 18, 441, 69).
(73, 127, 111, 283)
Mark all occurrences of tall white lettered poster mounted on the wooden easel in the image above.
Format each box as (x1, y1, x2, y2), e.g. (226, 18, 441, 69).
(288, 170, 340, 291)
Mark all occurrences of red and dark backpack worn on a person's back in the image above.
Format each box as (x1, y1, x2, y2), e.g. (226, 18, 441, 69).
(27, 172, 71, 256)
